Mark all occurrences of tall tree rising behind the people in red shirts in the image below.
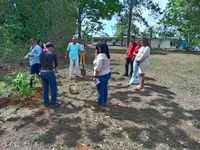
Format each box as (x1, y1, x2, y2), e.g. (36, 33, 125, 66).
(123, 0, 160, 44)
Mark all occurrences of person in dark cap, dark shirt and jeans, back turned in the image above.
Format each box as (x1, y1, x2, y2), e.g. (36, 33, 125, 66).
(40, 42, 59, 107)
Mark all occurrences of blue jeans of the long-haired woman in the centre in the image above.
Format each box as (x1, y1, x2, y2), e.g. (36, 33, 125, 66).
(97, 73, 111, 105)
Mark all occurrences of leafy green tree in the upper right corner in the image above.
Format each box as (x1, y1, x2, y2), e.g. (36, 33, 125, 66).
(162, 0, 200, 44)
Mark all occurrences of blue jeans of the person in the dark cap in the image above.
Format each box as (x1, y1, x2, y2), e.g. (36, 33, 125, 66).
(40, 71, 57, 106)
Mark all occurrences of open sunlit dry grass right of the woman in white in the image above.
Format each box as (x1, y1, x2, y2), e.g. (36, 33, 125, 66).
(148, 50, 200, 96)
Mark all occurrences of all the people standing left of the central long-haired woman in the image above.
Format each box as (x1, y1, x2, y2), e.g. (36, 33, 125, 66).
(24, 37, 87, 107)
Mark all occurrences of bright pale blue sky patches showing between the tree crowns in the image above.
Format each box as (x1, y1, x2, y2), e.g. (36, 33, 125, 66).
(103, 0, 168, 36)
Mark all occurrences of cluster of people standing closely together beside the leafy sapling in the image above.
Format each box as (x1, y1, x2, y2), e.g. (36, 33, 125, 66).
(24, 38, 59, 107)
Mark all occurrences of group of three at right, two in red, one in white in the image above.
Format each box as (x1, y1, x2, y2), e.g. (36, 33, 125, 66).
(123, 35, 150, 89)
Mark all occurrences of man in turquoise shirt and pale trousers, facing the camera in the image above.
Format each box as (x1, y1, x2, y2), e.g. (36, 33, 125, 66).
(65, 37, 80, 80)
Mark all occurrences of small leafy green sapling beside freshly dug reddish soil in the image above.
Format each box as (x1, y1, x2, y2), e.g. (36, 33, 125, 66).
(13, 73, 39, 99)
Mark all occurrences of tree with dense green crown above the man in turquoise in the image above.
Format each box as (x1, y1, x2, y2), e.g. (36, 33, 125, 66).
(74, 0, 122, 40)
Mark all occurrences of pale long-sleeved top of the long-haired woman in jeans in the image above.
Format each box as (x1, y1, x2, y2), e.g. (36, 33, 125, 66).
(93, 53, 110, 76)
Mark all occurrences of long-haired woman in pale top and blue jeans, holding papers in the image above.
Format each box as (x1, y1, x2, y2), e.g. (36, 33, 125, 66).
(93, 42, 111, 112)
